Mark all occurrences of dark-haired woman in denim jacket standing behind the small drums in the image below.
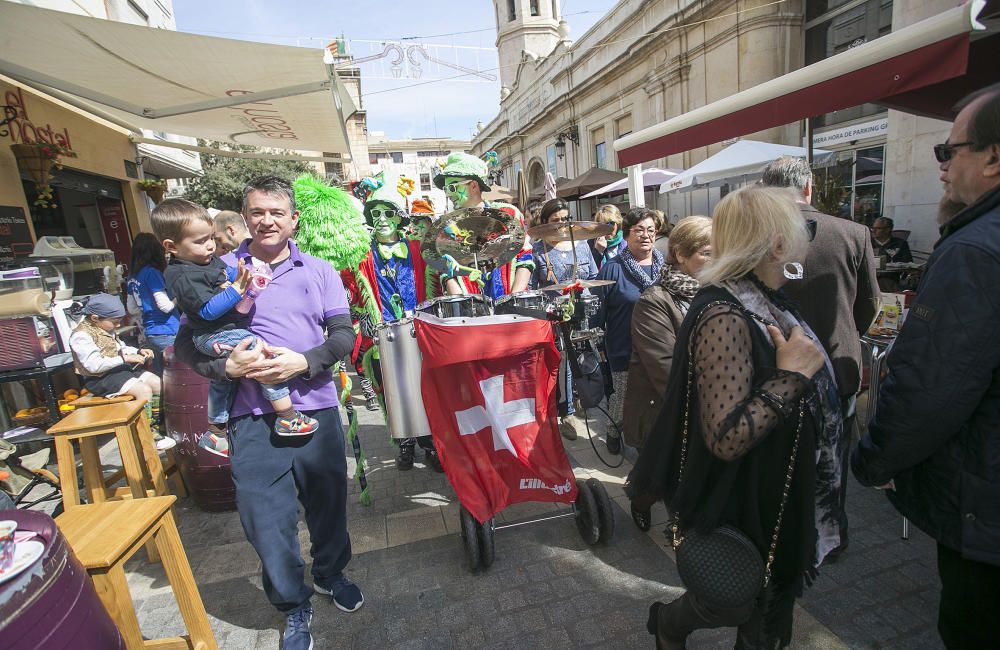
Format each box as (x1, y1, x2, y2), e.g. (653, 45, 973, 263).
(528, 199, 597, 440)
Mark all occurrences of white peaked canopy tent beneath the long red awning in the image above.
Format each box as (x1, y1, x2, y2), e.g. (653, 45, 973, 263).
(660, 140, 834, 194)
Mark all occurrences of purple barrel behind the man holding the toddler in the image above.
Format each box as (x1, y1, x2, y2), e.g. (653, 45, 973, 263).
(160, 347, 236, 512)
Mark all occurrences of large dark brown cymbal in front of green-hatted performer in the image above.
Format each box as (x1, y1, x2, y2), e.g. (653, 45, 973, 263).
(420, 208, 524, 271)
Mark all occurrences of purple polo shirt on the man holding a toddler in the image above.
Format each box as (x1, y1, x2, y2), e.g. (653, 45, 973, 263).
(222, 240, 349, 417)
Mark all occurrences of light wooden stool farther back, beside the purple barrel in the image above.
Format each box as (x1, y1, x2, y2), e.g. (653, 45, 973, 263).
(48, 400, 187, 511)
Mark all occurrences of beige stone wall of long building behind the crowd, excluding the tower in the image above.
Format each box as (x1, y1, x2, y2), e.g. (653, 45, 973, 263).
(472, 0, 803, 216)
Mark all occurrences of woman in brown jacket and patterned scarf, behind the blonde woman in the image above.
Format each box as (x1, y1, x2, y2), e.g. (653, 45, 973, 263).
(622, 217, 712, 530)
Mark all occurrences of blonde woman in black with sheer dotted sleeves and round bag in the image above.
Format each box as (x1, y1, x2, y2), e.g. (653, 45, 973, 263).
(629, 187, 842, 649)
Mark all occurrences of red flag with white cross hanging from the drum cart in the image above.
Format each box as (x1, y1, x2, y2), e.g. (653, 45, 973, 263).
(415, 314, 576, 522)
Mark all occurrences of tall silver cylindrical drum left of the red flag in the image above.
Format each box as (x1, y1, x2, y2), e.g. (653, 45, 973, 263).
(375, 317, 431, 438)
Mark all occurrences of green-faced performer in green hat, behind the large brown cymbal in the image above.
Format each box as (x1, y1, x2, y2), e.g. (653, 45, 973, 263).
(434, 152, 535, 300)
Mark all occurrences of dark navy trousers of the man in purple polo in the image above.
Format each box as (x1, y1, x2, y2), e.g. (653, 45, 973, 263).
(229, 408, 351, 613)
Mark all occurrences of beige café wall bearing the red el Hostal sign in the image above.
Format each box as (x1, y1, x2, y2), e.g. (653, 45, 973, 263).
(0, 78, 150, 236)
